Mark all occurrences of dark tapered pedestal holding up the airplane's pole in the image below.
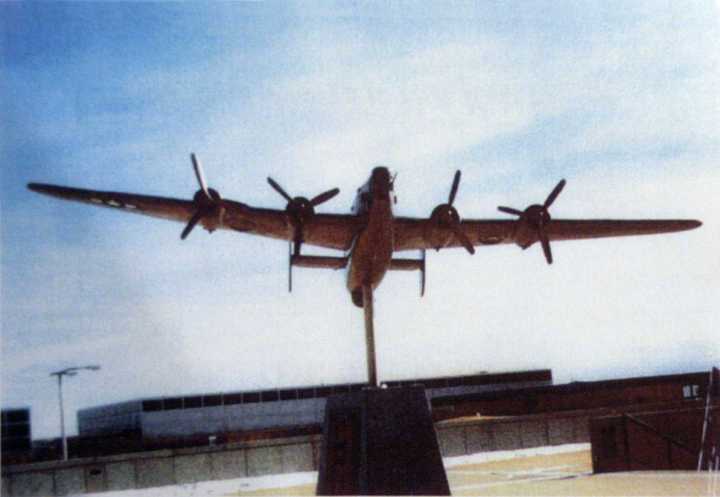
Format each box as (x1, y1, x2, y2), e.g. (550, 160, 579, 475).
(317, 386, 450, 495)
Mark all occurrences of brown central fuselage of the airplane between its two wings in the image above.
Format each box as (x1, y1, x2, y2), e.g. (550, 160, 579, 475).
(347, 167, 394, 307)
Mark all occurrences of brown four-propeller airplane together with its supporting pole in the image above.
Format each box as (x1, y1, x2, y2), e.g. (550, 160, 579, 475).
(27, 154, 702, 385)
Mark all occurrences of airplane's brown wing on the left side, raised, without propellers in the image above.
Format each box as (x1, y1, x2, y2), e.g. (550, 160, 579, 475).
(28, 183, 365, 250)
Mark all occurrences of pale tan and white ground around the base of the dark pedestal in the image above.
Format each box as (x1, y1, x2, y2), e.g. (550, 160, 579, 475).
(85, 444, 720, 497)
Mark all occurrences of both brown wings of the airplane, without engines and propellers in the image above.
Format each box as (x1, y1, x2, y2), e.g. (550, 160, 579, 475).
(28, 183, 702, 251)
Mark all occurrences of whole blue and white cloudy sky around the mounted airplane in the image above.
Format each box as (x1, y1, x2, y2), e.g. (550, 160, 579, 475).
(0, 1, 720, 438)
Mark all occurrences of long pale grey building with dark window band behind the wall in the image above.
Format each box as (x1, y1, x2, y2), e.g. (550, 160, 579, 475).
(78, 370, 552, 443)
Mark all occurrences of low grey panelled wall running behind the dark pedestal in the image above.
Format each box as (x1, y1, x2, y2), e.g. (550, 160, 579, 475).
(2, 408, 589, 497)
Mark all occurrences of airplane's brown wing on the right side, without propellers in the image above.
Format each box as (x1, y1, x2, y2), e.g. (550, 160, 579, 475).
(395, 217, 702, 251)
